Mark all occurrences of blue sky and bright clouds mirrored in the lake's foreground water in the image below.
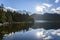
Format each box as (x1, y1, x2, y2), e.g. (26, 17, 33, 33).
(3, 28, 60, 40)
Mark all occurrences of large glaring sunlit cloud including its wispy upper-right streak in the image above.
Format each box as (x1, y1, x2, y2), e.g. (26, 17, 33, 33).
(35, 3, 52, 14)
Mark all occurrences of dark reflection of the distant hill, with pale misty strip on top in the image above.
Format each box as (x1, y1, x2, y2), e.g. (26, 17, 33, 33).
(33, 20, 60, 29)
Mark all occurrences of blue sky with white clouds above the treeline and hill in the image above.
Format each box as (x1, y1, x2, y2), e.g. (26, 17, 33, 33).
(0, 0, 60, 13)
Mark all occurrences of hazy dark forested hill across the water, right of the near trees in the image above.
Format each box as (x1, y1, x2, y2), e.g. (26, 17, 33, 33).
(31, 13, 60, 21)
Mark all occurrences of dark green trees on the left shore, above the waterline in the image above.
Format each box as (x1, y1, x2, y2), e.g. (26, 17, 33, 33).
(0, 4, 33, 23)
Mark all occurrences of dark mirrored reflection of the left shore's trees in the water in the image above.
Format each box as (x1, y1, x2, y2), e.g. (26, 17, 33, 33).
(0, 23, 33, 40)
